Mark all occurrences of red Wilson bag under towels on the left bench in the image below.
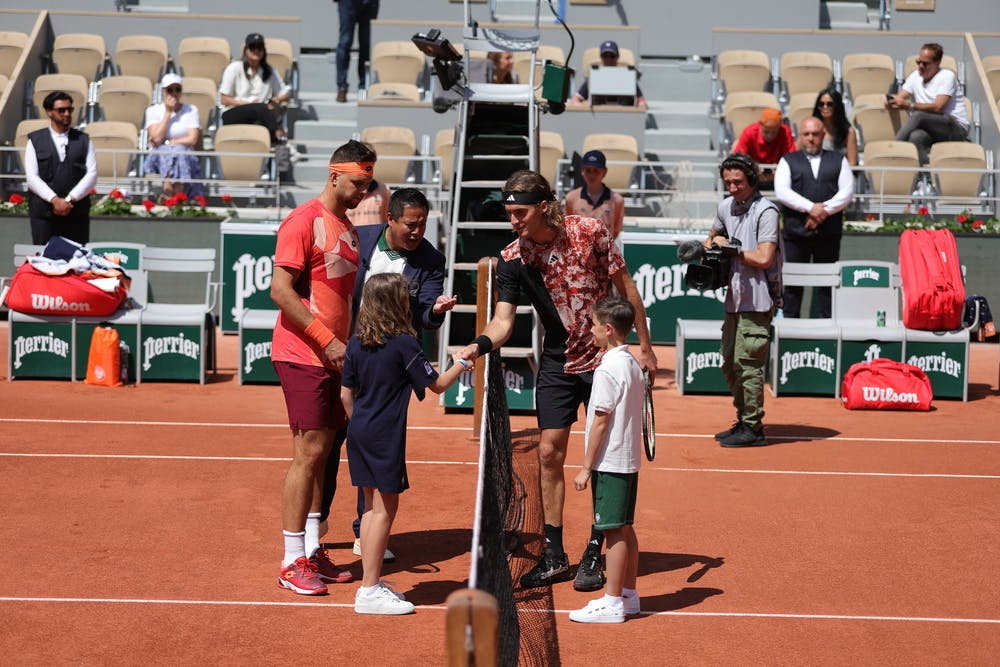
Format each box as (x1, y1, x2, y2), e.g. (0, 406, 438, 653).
(7, 262, 128, 317)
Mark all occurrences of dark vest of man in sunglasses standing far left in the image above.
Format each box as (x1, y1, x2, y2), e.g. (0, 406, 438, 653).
(28, 127, 90, 222)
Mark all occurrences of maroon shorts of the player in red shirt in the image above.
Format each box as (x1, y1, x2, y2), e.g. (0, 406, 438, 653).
(274, 361, 347, 431)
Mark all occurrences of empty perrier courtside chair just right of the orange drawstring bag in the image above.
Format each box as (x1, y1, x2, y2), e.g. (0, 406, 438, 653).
(137, 247, 218, 384)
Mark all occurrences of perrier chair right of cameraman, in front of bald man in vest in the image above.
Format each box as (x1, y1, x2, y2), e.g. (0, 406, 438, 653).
(771, 262, 840, 396)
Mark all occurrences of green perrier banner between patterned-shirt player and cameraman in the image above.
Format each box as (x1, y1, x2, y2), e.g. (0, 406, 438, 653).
(622, 232, 726, 345)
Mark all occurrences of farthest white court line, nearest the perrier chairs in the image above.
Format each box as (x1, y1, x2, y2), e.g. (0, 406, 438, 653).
(0, 417, 1000, 445)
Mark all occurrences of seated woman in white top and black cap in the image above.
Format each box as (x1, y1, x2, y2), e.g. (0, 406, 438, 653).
(219, 32, 291, 144)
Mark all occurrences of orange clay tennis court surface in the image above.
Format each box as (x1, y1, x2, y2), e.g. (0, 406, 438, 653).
(0, 326, 1000, 665)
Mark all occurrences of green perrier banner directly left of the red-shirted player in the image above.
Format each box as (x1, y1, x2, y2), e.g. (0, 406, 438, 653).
(219, 220, 279, 333)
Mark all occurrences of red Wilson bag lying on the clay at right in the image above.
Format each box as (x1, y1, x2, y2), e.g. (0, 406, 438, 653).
(840, 359, 933, 410)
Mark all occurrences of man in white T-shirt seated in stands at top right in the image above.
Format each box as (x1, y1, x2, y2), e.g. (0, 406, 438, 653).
(885, 42, 969, 164)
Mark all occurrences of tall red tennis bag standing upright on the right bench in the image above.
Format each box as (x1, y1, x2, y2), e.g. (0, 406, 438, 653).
(899, 229, 965, 331)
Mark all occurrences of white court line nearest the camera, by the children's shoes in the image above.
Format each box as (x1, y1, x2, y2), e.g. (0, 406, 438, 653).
(0, 596, 1000, 625)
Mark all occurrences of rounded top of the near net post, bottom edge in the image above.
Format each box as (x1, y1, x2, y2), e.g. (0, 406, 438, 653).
(445, 588, 499, 667)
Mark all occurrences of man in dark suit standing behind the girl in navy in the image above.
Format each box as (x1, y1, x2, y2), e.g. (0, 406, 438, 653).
(320, 188, 458, 561)
